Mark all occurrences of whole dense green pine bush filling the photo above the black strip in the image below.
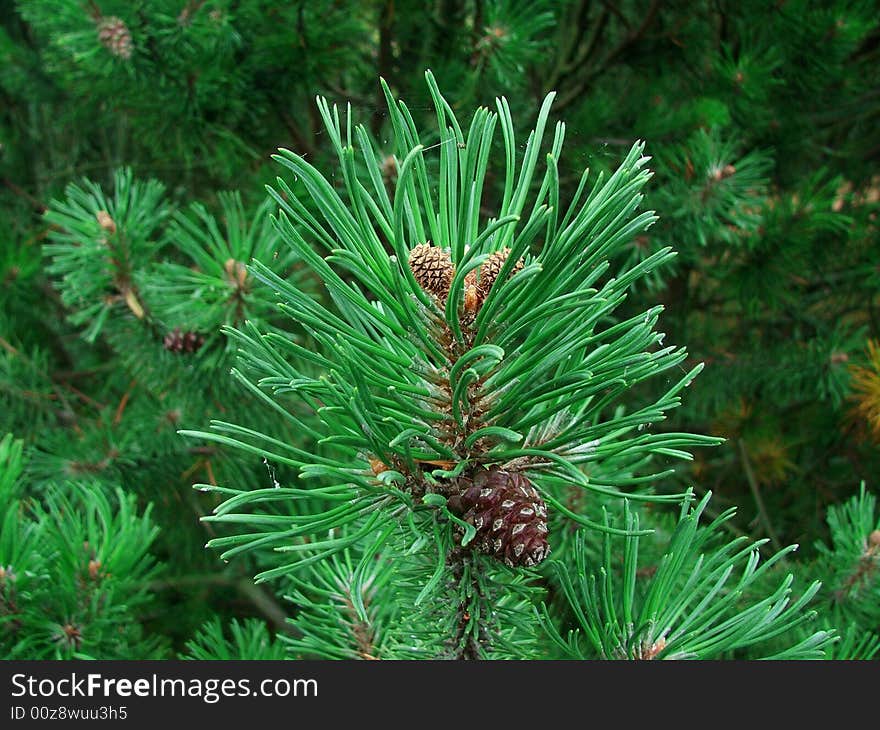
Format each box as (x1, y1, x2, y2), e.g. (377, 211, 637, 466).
(0, 0, 880, 659)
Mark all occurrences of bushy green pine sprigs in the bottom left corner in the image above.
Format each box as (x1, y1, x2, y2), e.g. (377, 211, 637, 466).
(0, 435, 166, 659)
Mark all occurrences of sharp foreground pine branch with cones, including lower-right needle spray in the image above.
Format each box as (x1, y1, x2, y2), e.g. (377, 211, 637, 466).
(177, 74, 844, 659)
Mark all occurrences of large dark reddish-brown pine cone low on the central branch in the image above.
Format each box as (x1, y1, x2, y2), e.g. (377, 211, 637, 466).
(448, 467, 550, 567)
